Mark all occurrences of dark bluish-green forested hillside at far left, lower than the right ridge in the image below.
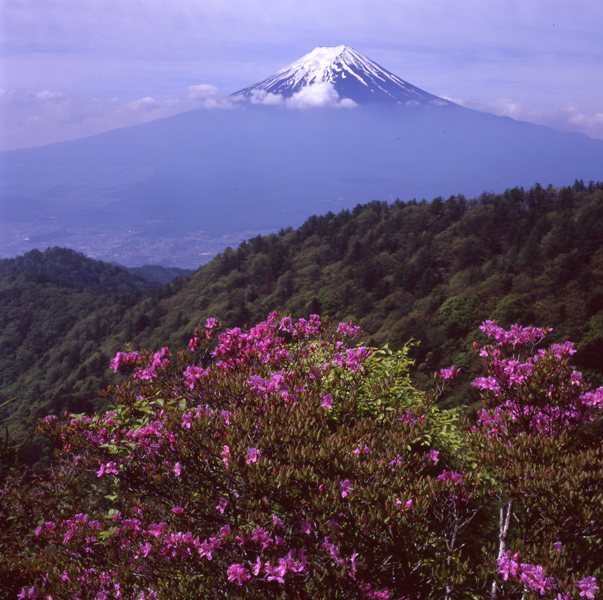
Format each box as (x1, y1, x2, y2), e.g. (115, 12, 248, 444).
(0, 248, 158, 458)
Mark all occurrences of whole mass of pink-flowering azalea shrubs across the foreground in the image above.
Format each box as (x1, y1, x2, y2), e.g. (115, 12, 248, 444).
(0, 313, 603, 598)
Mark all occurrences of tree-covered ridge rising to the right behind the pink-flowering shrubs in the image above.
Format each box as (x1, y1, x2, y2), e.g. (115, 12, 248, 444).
(130, 182, 603, 392)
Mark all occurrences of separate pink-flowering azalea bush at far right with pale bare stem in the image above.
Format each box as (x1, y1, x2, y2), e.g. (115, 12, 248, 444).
(473, 321, 603, 600)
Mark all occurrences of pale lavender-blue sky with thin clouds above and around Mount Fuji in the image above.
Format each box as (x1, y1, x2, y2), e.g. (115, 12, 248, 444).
(0, 0, 603, 148)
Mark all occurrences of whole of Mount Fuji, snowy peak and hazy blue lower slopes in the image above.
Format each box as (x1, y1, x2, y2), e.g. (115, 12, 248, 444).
(0, 46, 603, 268)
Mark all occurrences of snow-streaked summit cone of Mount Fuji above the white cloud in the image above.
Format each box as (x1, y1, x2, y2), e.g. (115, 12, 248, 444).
(233, 45, 449, 105)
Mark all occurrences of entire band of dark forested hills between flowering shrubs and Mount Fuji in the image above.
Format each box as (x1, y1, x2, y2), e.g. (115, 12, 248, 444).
(0, 182, 603, 460)
